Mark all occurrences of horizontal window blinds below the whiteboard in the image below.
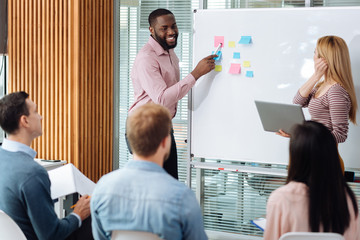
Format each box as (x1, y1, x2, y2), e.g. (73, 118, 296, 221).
(191, 159, 360, 239)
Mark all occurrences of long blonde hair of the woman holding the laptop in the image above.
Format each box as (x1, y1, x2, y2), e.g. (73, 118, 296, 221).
(316, 36, 358, 124)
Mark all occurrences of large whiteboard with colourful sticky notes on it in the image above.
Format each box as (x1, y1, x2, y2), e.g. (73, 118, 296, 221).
(190, 7, 360, 168)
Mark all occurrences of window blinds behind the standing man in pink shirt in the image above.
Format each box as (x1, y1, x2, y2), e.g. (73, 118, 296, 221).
(117, 0, 199, 182)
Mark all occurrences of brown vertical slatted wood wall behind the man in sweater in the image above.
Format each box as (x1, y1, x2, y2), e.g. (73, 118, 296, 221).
(8, 0, 113, 181)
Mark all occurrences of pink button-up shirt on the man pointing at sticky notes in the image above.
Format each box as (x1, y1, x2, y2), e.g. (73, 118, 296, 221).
(129, 36, 195, 117)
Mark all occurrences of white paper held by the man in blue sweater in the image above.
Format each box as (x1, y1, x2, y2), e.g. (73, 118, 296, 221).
(48, 163, 96, 199)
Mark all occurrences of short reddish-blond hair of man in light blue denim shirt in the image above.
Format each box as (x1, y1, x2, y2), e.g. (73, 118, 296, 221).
(126, 103, 171, 157)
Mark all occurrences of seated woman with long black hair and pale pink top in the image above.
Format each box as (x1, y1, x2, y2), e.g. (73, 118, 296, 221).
(264, 121, 360, 240)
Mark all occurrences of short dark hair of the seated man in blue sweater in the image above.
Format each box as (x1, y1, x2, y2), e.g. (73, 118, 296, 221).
(0, 92, 29, 134)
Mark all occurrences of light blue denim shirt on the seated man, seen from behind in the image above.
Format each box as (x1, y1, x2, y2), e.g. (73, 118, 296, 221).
(90, 160, 207, 240)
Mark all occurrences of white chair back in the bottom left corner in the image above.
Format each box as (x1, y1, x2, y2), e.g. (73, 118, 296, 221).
(0, 210, 26, 240)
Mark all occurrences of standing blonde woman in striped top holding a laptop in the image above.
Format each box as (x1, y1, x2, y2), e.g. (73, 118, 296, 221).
(278, 36, 357, 171)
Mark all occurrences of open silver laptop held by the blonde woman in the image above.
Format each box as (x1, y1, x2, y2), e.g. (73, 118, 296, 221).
(255, 100, 305, 133)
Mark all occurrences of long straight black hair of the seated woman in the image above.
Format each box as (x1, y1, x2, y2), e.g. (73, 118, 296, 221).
(287, 121, 358, 234)
